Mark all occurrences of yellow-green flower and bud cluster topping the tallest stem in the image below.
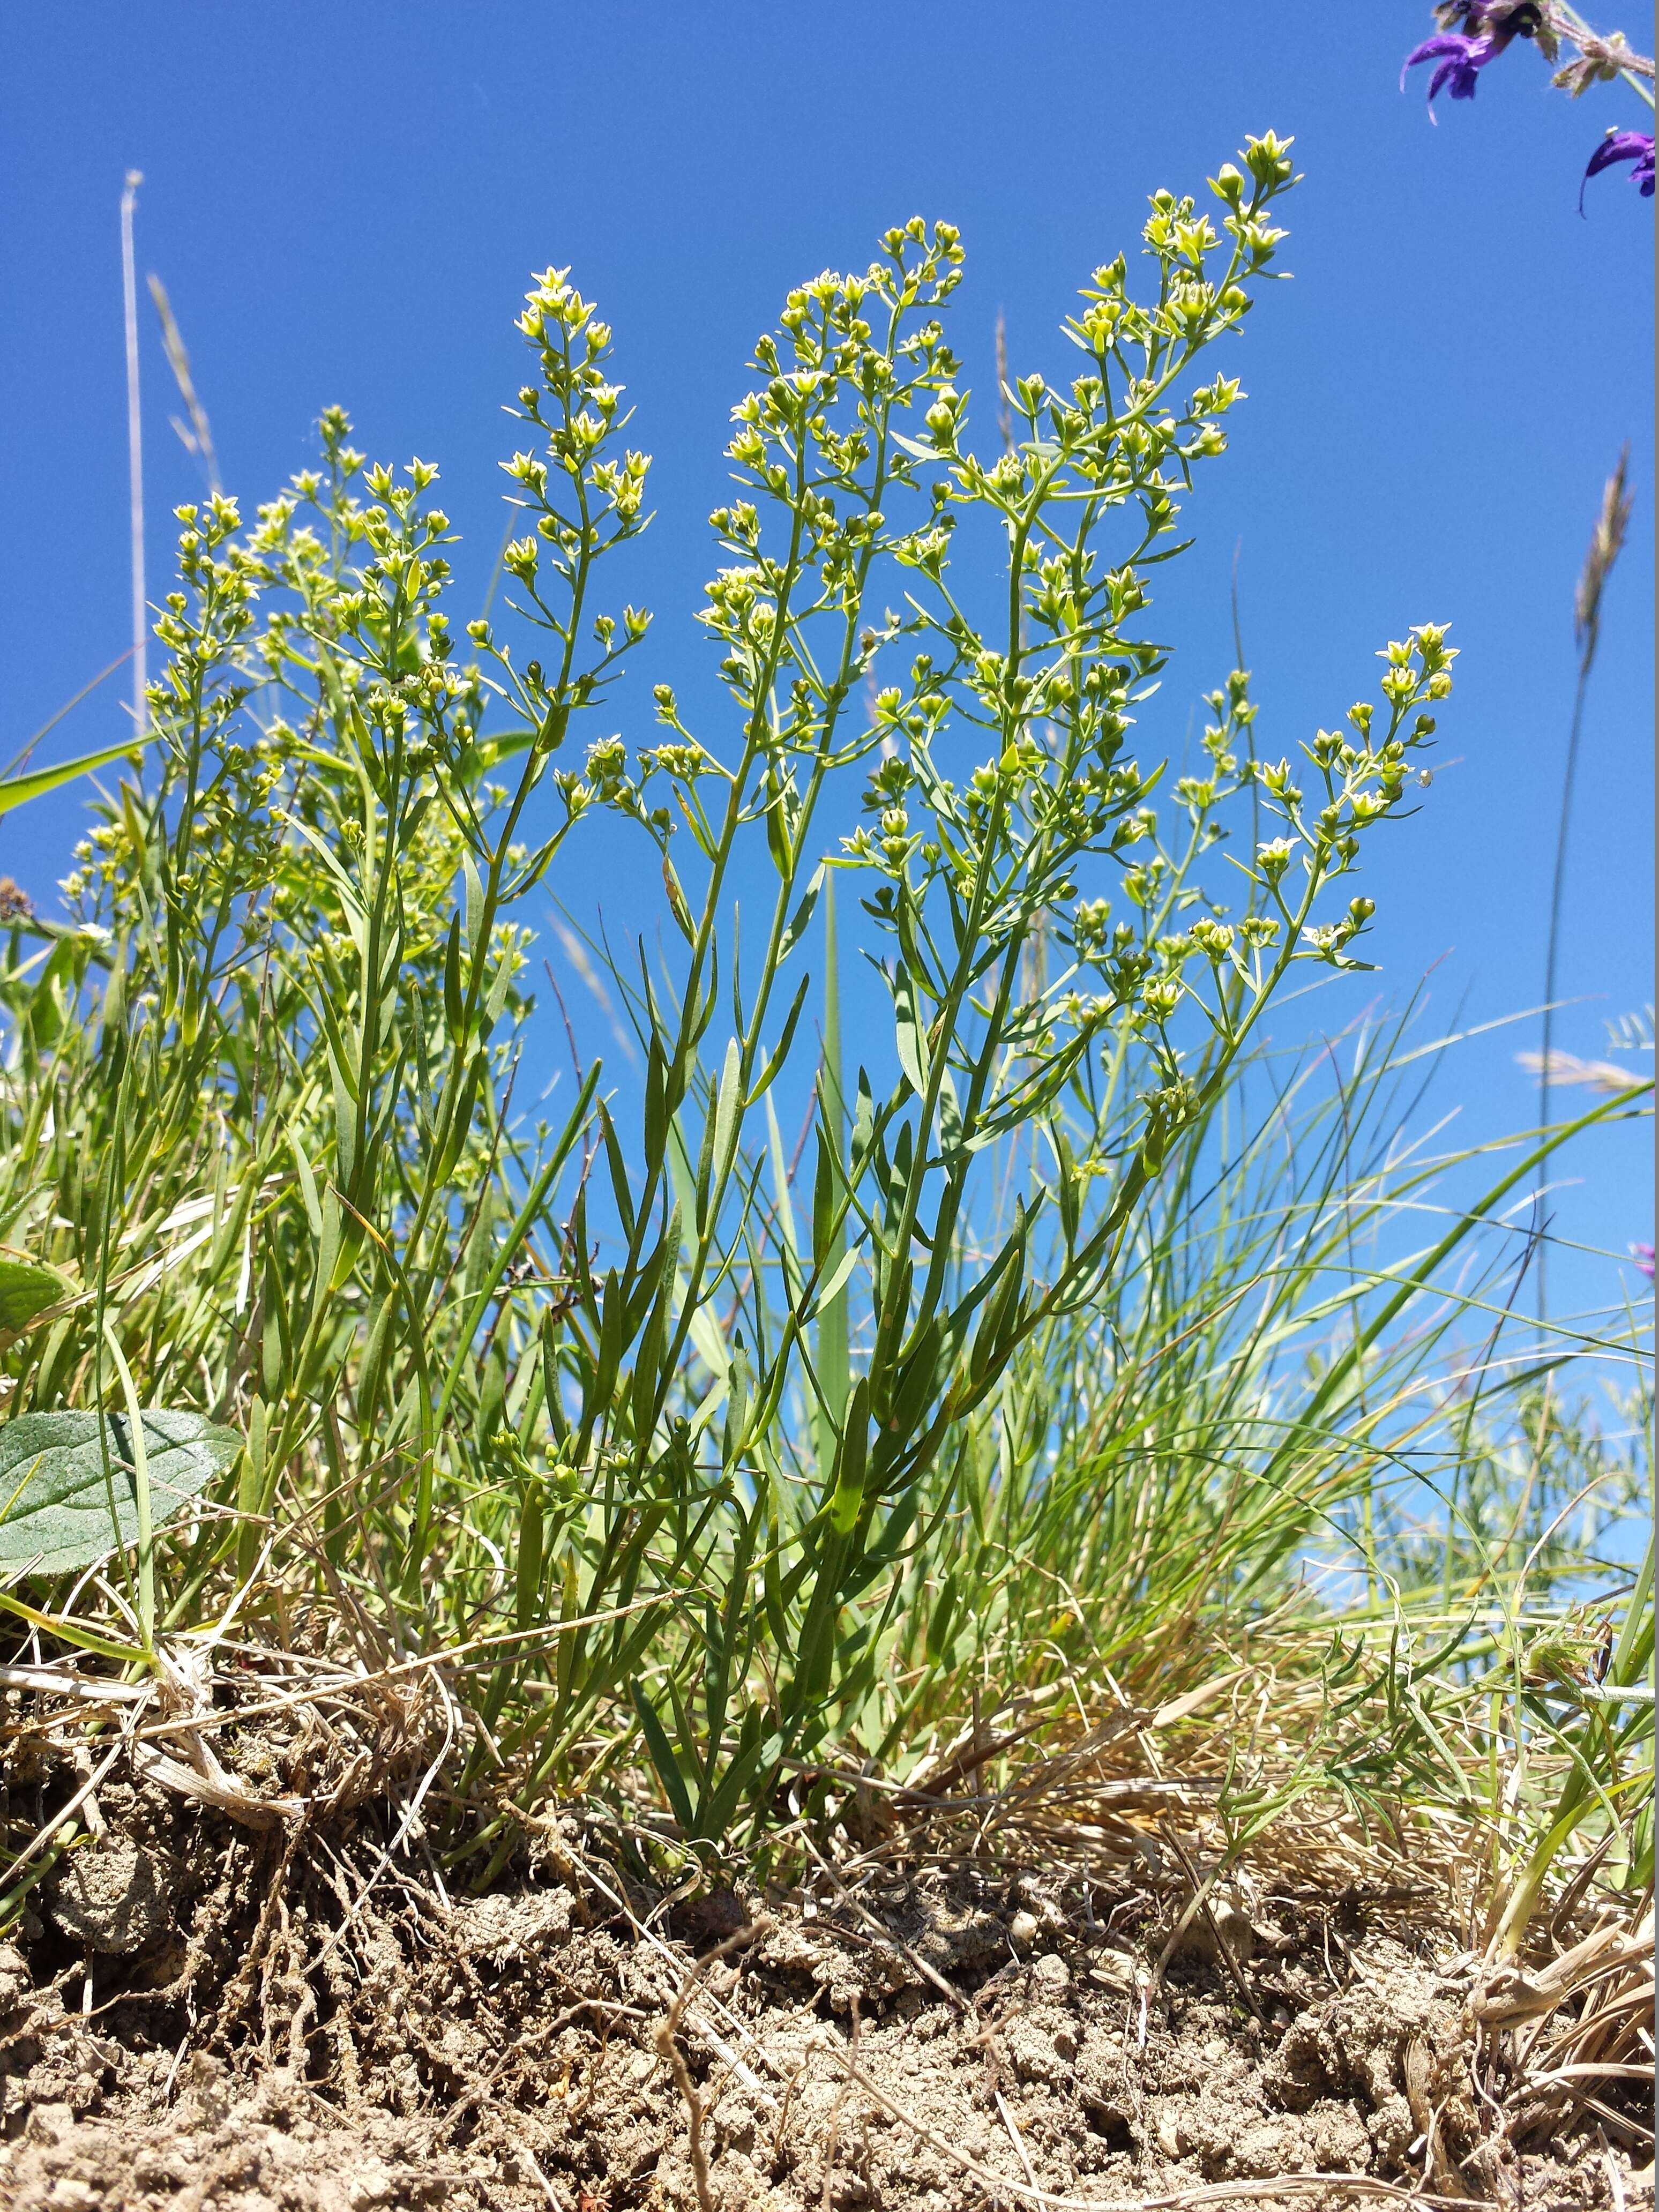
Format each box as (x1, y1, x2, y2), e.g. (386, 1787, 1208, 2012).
(832, 139, 1292, 1093)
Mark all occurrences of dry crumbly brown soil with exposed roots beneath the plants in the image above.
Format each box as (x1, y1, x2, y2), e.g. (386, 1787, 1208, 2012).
(0, 1781, 1653, 2212)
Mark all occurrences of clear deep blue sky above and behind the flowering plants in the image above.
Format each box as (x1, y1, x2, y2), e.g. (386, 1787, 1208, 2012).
(0, 0, 1653, 1301)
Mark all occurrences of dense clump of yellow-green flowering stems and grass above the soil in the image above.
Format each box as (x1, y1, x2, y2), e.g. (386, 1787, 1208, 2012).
(0, 137, 1650, 1938)
